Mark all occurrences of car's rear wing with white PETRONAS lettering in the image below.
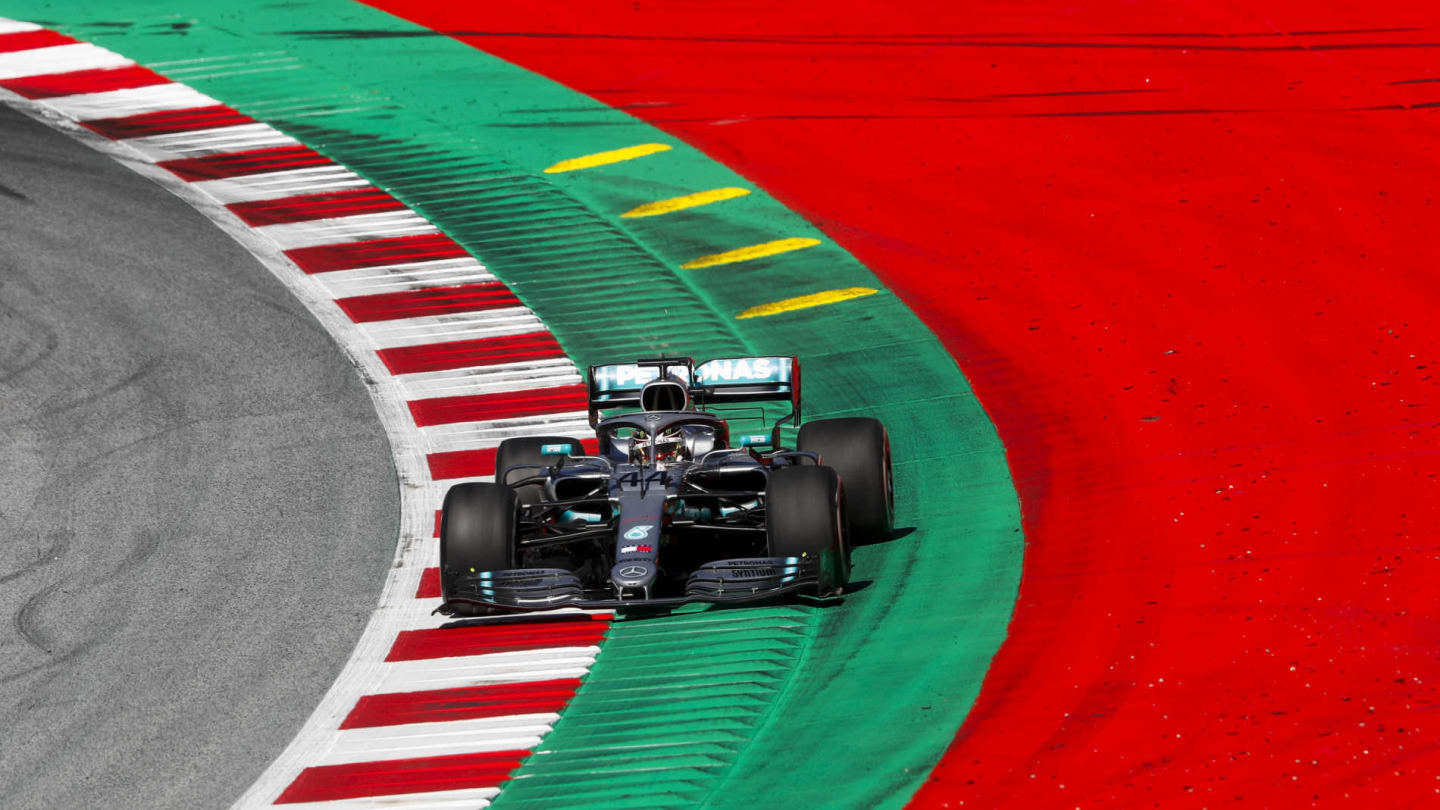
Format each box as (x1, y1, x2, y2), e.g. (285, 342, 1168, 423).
(586, 356, 801, 428)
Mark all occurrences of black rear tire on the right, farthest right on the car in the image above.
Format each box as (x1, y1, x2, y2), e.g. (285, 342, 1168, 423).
(796, 417, 896, 543)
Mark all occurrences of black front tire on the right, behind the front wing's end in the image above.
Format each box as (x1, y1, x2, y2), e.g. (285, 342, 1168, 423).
(765, 466, 850, 597)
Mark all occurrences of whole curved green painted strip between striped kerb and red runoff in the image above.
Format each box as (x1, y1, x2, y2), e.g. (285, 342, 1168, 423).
(0, 0, 1022, 810)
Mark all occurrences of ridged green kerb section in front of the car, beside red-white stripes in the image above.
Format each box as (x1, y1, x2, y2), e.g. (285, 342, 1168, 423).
(503, 605, 818, 807)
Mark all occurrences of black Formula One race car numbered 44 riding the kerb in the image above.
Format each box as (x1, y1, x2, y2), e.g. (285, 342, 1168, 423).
(439, 357, 894, 614)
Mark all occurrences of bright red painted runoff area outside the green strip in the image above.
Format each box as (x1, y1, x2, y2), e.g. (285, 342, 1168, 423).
(377, 0, 1440, 807)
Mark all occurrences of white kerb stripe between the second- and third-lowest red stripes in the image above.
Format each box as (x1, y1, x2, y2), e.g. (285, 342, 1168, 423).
(370, 642, 600, 695)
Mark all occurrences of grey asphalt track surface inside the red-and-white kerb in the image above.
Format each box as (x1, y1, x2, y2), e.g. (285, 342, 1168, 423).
(0, 107, 399, 809)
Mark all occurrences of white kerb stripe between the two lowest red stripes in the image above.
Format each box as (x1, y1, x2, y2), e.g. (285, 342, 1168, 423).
(315, 712, 560, 765)
